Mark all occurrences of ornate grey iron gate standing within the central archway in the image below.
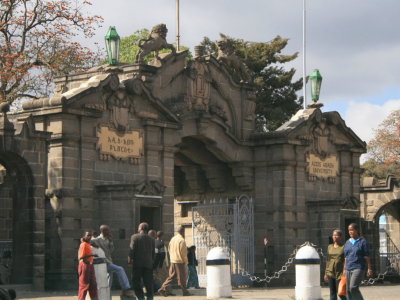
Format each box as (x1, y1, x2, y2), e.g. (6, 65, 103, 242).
(192, 195, 254, 287)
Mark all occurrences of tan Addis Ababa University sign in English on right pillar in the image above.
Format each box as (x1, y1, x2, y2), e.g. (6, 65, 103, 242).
(307, 154, 339, 178)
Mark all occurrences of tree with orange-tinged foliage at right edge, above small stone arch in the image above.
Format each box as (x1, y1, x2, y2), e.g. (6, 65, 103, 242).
(362, 109, 400, 179)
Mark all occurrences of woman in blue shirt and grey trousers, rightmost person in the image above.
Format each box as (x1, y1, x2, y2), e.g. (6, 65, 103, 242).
(343, 223, 372, 300)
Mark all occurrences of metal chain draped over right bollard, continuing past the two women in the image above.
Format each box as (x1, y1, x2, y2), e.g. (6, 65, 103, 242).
(241, 242, 400, 285)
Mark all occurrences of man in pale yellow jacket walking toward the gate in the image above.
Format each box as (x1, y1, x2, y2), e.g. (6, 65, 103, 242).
(158, 226, 191, 296)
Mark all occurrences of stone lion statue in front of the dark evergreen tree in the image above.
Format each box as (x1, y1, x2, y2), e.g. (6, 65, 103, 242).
(217, 38, 250, 82)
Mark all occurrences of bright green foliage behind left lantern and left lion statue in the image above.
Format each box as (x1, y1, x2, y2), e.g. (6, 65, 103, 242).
(120, 28, 191, 64)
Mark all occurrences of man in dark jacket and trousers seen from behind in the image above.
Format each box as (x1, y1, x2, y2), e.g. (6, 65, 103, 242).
(129, 223, 155, 300)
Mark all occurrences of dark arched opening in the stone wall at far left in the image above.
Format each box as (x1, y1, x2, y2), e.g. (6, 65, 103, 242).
(0, 152, 34, 284)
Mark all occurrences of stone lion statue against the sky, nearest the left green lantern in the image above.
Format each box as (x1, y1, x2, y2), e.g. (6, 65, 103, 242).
(136, 24, 176, 63)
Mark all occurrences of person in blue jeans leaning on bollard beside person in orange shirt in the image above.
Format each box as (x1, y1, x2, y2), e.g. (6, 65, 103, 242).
(93, 225, 133, 297)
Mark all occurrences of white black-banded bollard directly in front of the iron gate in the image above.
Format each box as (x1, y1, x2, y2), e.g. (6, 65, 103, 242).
(206, 247, 232, 299)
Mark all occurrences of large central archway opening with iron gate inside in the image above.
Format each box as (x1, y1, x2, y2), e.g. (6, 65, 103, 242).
(174, 134, 254, 286)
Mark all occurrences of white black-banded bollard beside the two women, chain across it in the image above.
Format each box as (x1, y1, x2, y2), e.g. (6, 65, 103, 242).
(295, 246, 322, 300)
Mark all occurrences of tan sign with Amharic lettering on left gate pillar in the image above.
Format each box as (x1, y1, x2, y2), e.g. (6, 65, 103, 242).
(97, 126, 143, 162)
